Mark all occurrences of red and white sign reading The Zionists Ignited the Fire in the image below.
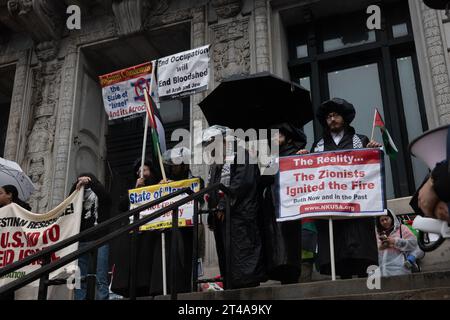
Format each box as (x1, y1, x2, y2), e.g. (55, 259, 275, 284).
(277, 149, 386, 221)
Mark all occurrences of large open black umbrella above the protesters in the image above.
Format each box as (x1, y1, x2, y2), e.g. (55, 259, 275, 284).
(199, 72, 313, 130)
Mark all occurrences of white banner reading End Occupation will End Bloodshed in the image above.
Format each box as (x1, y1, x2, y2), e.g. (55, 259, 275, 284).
(157, 45, 210, 100)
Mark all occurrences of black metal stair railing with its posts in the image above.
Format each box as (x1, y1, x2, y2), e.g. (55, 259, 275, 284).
(0, 184, 225, 299)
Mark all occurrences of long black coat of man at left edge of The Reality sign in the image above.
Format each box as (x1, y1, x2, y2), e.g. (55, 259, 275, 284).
(260, 144, 302, 283)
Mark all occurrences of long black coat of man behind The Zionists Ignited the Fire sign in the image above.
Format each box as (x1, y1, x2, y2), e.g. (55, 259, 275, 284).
(312, 127, 378, 277)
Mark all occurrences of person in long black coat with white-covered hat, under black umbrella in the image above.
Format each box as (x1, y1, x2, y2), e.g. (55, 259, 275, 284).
(202, 126, 267, 289)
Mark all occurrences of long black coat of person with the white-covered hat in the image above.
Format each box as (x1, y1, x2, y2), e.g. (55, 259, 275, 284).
(208, 149, 266, 288)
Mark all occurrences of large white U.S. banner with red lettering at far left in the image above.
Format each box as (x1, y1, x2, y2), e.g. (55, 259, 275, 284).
(0, 189, 84, 299)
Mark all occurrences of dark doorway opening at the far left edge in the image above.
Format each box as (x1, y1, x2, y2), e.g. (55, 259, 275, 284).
(0, 66, 15, 157)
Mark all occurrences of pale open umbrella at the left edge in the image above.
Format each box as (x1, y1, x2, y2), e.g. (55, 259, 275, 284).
(0, 158, 35, 201)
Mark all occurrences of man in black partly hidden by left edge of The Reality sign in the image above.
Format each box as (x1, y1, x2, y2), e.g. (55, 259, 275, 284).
(260, 123, 308, 284)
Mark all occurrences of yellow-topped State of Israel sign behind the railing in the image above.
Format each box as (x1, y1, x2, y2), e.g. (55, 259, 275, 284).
(128, 178, 200, 231)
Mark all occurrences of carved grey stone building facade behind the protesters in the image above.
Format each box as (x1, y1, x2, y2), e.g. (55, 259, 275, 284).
(0, 0, 450, 276)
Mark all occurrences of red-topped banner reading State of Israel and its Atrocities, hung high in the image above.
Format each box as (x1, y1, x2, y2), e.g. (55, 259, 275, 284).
(99, 62, 153, 120)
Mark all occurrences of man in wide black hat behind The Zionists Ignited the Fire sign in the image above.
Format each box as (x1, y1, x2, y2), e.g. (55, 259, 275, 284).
(312, 98, 382, 279)
